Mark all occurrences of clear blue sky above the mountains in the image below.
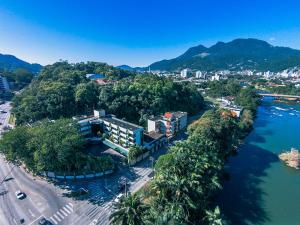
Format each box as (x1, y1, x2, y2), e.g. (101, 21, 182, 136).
(0, 0, 300, 66)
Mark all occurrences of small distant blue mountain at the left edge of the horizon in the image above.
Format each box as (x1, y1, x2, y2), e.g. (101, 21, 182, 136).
(0, 54, 42, 74)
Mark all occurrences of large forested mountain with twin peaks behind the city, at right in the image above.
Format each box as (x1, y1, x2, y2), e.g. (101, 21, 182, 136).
(150, 38, 300, 71)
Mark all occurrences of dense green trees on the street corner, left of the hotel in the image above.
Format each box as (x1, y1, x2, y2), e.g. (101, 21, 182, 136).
(0, 119, 113, 173)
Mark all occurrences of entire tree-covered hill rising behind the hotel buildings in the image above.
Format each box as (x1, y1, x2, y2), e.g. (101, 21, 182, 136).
(13, 62, 203, 124)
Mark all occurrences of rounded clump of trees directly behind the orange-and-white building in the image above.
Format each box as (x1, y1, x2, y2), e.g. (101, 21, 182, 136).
(99, 75, 203, 124)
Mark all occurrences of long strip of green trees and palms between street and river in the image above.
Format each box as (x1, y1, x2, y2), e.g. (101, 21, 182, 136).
(111, 81, 259, 225)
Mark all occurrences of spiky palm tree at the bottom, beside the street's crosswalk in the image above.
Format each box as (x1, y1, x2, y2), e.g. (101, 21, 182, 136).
(109, 194, 148, 225)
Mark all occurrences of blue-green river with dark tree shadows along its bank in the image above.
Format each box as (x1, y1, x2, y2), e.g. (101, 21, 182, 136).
(219, 98, 300, 225)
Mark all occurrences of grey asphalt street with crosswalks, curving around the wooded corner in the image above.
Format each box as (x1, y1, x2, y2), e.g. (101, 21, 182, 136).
(0, 102, 178, 225)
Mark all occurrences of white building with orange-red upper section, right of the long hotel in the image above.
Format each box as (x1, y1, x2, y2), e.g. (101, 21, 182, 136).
(148, 112, 187, 138)
